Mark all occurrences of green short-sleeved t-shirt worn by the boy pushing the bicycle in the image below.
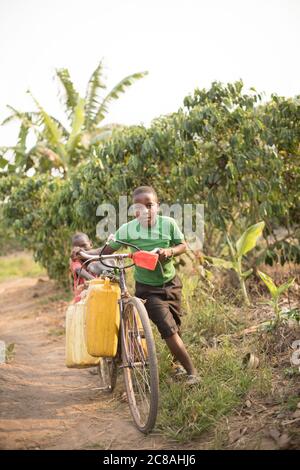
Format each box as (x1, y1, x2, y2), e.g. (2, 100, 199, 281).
(109, 215, 184, 286)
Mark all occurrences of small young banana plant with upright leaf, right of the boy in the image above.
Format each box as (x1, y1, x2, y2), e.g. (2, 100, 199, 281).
(205, 222, 265, 305)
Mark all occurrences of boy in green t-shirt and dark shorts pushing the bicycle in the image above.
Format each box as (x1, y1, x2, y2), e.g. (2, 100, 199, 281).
(103, 186, 199, 385)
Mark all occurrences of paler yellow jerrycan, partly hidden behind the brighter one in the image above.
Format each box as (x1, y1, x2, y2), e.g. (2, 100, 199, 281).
(66, 301, 100, 368)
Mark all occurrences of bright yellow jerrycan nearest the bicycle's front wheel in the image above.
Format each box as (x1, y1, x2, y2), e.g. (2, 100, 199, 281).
(85, 277, 121, 357)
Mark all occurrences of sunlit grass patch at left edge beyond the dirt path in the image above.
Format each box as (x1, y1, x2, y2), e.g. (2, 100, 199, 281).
(0, 252, 46, 282)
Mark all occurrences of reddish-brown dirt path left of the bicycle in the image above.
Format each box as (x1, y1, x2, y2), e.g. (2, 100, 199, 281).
(0, 278, 192, 449)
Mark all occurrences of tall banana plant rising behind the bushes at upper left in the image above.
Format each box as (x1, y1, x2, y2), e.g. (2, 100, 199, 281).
(0, 61, 147, 174)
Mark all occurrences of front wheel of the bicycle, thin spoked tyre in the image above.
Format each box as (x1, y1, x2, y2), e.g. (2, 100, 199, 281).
(122, 297, 159, 434)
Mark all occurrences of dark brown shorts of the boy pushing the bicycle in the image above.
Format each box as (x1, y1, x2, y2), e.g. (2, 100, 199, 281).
(135, 275, 182, 339)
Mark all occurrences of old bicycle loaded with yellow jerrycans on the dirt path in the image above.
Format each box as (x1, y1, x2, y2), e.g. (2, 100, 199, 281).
(80, 241, 159, 434)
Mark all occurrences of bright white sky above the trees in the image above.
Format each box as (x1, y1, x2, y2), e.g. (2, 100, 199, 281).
(0, 0, 300, 145)
